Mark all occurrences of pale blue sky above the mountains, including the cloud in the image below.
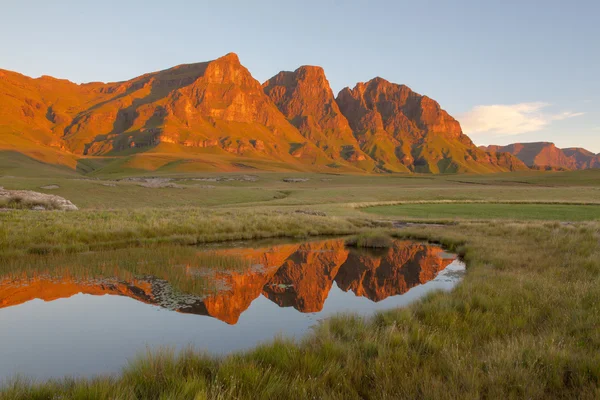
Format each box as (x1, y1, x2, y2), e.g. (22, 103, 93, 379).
(0, 0, 600, 152)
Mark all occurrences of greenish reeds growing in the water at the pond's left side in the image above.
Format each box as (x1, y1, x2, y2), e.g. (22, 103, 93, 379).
(0, 246, 252, 297)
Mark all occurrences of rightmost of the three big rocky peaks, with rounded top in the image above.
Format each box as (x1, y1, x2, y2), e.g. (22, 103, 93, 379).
(337, 78, 526, 173)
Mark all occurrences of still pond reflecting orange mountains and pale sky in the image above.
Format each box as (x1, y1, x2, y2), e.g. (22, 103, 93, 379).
(0, 239, 465, 381)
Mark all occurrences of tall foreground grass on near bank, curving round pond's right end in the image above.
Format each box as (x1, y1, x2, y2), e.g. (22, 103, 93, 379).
(0, 221, 600, 399)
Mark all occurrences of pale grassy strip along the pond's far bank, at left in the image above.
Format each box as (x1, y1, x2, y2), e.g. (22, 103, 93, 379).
(0, 208, 372, 257)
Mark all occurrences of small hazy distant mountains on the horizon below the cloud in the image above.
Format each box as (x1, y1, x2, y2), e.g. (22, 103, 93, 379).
(480, 142, 600, 170)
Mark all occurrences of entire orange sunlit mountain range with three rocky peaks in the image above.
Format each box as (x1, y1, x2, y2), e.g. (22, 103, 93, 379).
(0, 53, 597, 173)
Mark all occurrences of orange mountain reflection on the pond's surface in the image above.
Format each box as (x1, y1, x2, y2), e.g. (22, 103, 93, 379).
(0, 239, 453, 324)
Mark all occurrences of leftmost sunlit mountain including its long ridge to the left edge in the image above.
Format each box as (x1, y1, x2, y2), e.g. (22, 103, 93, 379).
(0, 54, 342, 169)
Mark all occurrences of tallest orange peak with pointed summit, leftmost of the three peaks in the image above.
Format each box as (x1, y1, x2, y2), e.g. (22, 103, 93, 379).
(66, 54, 330, 164)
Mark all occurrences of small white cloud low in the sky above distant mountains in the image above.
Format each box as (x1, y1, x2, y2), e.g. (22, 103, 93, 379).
(458, 102, 583, 136)
